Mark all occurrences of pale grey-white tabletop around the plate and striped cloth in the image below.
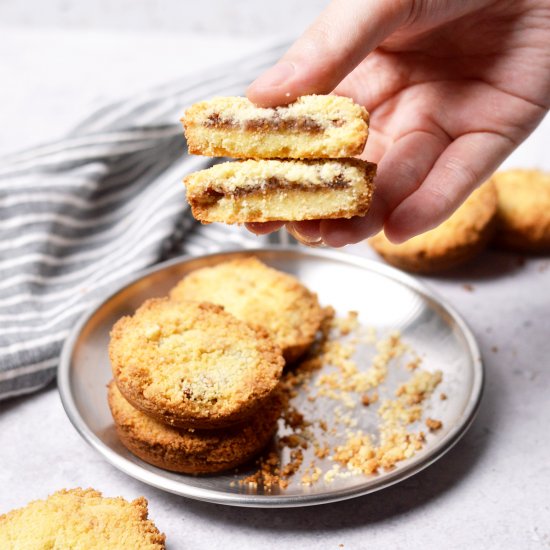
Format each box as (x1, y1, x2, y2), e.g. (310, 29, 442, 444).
(0, 21, 550, 550)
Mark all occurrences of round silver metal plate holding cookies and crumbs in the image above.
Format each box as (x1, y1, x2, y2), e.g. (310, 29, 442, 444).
(58, 247, 483, 507)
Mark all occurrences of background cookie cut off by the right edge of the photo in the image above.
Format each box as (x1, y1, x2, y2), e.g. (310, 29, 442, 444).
(493, 170, 550, 253)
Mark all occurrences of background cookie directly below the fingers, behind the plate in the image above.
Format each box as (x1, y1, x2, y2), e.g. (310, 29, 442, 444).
(369, 180, 497, 273)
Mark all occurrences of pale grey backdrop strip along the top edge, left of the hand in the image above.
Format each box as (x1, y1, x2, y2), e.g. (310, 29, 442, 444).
(0, 0, 329, 36)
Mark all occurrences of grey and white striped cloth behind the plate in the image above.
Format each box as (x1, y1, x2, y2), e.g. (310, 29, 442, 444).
(0, 42, 292, 399)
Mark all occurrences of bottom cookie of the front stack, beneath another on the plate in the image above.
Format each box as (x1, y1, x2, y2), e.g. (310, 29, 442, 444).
(109, 382, 282, 474)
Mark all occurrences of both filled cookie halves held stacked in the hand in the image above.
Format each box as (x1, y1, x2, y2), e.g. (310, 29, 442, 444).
(182, 95, 376, 224)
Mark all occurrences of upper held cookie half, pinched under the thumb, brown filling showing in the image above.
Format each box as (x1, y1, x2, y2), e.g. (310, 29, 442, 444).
(182, 95, 369, 159)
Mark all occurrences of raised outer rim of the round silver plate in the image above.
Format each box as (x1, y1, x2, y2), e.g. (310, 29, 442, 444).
(57, 245, 486, 508)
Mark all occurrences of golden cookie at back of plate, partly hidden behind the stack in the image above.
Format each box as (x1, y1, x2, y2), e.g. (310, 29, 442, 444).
(170, 257, 324, 361)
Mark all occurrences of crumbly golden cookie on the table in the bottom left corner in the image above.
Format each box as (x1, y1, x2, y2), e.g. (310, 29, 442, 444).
(0, 488, 165, 550)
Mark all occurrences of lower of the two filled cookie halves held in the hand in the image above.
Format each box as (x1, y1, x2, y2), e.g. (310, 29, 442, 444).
(184, 159, 376, 224)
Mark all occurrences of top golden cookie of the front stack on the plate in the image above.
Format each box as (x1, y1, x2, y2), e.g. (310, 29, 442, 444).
(109, 298, 284, 429)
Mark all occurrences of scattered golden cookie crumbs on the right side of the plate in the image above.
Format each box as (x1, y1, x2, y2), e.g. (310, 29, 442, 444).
(233, 308, 446, 493)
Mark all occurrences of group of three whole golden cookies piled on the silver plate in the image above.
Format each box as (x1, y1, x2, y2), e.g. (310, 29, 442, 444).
(109, 258, 323, 474)
